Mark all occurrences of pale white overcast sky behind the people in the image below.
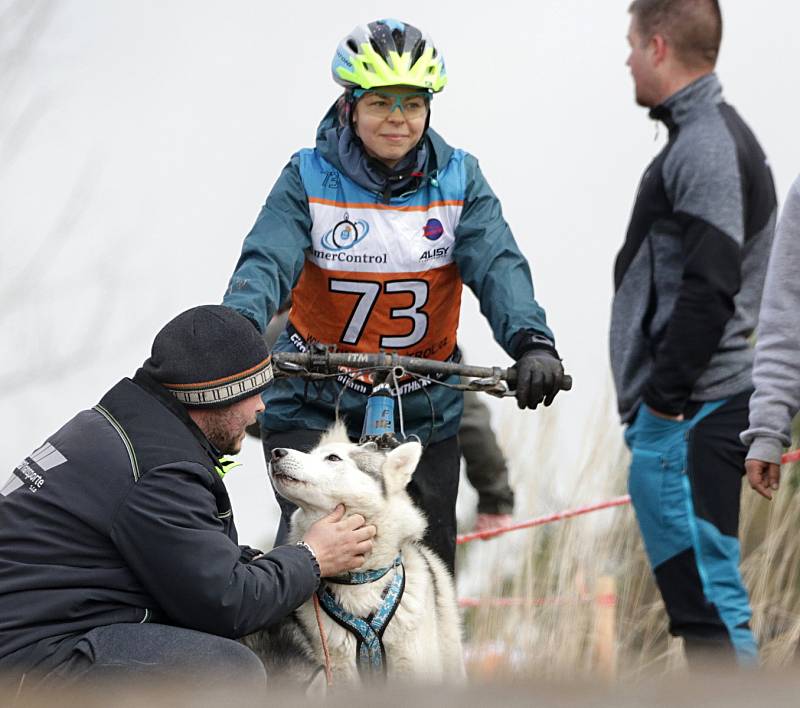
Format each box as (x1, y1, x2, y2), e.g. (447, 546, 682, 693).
(0, 0, 800, 541)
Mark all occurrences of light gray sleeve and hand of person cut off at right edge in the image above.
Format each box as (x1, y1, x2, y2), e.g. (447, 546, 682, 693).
(742, 177, 800, 499)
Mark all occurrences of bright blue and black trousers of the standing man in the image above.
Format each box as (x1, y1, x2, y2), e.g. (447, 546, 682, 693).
(625, 391, 758, 665)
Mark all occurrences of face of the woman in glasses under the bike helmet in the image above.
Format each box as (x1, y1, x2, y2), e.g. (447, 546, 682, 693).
(353, 86, 429, 167)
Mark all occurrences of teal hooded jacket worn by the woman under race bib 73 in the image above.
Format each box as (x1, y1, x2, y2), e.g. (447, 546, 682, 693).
(223, 108, 554, 442)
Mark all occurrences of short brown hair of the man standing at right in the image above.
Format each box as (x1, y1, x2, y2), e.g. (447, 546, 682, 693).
(628, 0, 722, 69)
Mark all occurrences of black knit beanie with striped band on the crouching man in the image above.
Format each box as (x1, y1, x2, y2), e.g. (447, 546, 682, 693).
(142, 305, 272, 408)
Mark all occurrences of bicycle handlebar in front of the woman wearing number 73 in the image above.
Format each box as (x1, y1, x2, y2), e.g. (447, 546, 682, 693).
(272, 349, 572, 393)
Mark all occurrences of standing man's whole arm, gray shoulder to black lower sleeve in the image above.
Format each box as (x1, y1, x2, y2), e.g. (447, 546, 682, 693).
(643, 131, 744, 416)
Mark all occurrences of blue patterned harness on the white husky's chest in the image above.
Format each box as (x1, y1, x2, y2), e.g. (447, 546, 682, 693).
(317, 554, 406, 678)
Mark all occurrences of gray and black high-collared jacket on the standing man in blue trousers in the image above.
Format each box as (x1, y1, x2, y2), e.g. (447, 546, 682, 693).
(610, 74, 776, 422)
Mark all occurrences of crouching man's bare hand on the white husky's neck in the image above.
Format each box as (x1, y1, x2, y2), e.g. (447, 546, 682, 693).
(303, 504, 377, 578)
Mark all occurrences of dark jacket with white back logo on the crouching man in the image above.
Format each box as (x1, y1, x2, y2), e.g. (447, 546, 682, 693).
(0, 371, 319, 670)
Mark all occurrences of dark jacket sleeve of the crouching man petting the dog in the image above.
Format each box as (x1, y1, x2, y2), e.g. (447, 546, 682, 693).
(111, 463, 319, 638)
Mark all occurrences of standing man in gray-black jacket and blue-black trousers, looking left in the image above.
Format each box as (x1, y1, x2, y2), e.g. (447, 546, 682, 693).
(610, 0, 776, 663)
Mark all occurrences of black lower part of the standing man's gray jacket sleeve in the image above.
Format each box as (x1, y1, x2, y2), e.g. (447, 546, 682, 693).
(643, 214, 741, 415)
